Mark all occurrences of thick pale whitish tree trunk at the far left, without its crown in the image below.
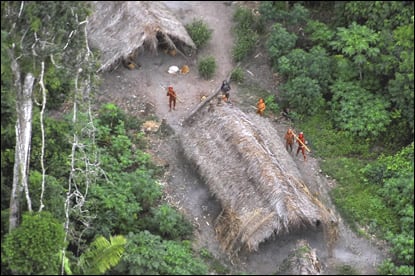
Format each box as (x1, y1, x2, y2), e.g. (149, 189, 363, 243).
(9, 52, 35, 231)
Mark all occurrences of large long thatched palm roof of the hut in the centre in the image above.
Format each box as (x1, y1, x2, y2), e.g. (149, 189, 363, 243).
(180, 104, 336, 255)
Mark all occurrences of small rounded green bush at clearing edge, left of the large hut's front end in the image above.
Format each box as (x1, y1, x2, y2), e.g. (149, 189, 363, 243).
(148, 204, 193, 240)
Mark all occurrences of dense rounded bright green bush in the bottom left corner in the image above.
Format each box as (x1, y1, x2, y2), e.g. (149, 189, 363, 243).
(2, 211, 65, 275)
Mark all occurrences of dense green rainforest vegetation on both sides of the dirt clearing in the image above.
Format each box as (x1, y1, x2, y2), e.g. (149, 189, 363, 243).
(1, 1, 414, 275)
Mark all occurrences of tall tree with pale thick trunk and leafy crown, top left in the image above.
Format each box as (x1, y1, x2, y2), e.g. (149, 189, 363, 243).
(1, 1, 93, 230)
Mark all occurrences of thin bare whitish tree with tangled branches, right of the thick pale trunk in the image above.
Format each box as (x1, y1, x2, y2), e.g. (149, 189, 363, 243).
(61, 21, 101, 275)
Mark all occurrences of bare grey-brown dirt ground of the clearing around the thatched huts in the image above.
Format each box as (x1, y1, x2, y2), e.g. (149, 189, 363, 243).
(98, 1, 386, 275)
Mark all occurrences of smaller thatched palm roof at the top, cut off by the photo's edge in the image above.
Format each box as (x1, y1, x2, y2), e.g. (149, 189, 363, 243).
(87, 1, 196, 71)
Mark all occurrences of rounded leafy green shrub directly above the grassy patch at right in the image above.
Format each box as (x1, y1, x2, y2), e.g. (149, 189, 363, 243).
(330, 81, 390, 138)
